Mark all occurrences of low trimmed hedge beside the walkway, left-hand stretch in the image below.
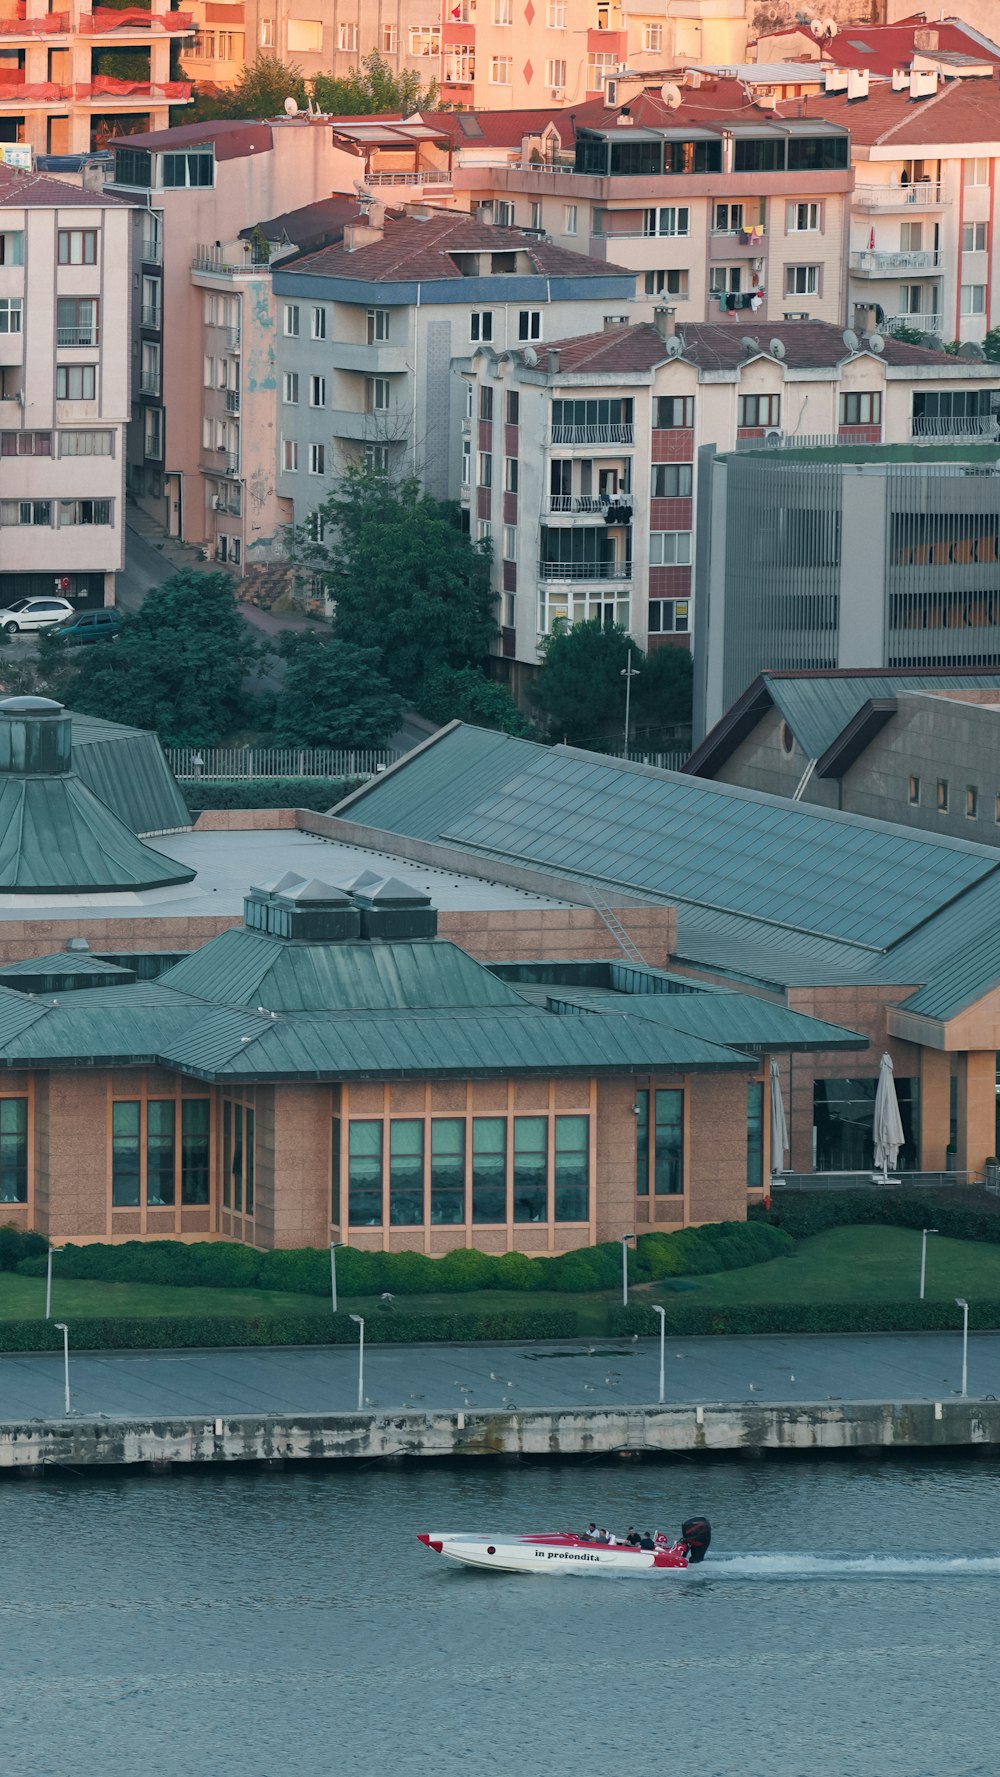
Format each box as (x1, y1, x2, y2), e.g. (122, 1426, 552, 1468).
(0, 1310, 577, 1351)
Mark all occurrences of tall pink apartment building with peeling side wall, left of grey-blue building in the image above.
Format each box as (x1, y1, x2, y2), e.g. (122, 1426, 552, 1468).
(107, 117, 362, 544)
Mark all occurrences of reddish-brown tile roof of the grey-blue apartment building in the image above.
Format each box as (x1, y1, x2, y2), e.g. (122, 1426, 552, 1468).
(288, 211, 634, 283)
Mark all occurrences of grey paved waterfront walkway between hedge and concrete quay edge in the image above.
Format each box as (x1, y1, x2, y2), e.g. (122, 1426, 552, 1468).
(0, 1333, 1000, 1422)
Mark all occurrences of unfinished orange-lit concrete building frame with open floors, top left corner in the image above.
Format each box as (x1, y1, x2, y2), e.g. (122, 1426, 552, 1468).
(0, 0, 194, 155)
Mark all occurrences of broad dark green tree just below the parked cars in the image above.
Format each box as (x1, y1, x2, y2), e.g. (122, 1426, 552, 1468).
(39, 574, 266, 746)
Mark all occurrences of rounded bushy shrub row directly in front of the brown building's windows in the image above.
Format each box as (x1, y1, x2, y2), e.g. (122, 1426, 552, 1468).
(9, 1223, 794, 1295)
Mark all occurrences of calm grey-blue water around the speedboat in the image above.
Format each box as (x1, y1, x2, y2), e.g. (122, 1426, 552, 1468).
(0, 1461, 1000, 1777)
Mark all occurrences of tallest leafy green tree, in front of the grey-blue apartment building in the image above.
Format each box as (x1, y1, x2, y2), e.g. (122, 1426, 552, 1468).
(290, 464, 497, 709)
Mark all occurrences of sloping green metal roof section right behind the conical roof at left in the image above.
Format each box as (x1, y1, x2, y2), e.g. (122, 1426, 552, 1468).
(73, 714, 192, 833)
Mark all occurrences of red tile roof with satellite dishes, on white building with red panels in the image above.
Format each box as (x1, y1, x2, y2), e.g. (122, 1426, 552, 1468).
(538, 315, 968, 375)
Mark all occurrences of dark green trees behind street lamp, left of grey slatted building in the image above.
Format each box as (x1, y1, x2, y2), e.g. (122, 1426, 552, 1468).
(529, 618, 691, 752)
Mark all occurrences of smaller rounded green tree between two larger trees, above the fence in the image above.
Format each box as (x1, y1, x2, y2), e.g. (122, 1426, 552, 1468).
(275, 629, 405, 748)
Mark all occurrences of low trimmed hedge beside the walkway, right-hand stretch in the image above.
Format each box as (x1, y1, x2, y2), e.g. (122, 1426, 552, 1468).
(607, 1303, 1000, 1338)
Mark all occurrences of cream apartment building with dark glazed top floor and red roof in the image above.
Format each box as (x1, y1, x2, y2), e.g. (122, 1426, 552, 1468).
(444, 75, 853, 323)
